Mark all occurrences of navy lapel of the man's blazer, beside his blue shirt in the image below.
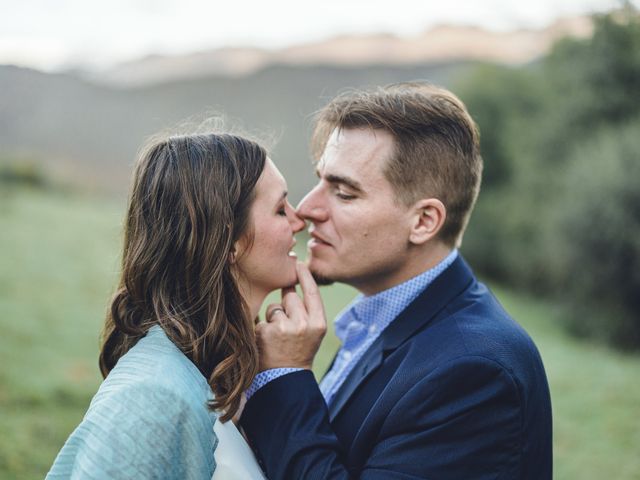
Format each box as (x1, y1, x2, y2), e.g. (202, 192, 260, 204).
(329, 255, 474, 421)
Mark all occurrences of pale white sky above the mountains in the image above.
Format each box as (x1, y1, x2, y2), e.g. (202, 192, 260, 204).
(0, 0, 639, 70)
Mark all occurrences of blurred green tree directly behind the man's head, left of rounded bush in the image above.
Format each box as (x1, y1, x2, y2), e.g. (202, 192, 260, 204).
(456, 65, 545, 282)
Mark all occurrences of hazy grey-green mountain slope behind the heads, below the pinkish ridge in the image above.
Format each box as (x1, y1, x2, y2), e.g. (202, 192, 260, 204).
(0, 62, 474, 201)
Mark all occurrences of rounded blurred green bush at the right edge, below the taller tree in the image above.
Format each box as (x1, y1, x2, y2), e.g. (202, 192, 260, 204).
(544, 117, 640, 348)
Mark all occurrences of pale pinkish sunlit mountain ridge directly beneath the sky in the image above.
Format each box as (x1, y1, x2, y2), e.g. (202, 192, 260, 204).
(89, 17, 593, 87)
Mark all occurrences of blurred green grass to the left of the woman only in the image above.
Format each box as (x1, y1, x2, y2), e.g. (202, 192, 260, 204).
(0, 186, 121, 479)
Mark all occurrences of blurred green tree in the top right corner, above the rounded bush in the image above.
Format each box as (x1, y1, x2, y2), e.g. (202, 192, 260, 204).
(541, 4, 640, 159)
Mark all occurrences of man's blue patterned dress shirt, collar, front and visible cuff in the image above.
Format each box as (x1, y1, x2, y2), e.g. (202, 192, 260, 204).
(247, 249, 458, 405)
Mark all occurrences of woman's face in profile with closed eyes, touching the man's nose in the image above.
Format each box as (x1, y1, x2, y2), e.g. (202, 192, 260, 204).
(236, 158, 305, 294)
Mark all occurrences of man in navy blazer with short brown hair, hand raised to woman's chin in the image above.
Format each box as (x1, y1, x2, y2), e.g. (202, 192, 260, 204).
(241, 83, 552, 480)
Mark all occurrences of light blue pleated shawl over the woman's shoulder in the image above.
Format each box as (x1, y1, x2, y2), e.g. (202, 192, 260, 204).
(46, 325, 218, 480)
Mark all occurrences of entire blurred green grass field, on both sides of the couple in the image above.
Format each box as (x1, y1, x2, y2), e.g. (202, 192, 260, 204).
(0, 186, 640, 480)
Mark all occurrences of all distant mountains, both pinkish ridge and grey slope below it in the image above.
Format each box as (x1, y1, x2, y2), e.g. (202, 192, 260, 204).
(0, 14, 591, 201)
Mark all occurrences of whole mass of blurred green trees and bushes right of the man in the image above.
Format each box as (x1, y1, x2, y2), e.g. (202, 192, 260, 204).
(459, 9, 640, 348)
